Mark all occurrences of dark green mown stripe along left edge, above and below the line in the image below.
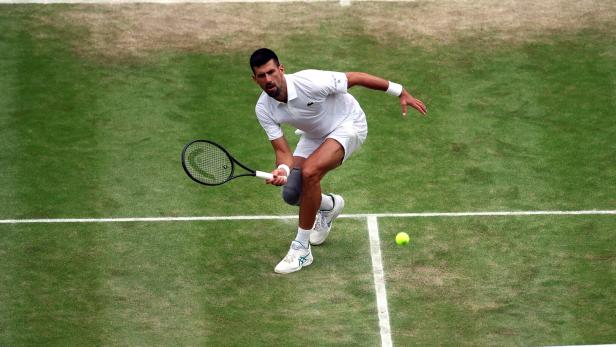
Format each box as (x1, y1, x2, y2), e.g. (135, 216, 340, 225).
(0, 7, 108, 345)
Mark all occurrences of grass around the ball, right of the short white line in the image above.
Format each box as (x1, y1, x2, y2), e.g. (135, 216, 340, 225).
(380, 217, 616, 346)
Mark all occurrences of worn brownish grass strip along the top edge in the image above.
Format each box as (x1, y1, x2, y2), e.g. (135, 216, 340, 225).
(33, 0, 616, 58)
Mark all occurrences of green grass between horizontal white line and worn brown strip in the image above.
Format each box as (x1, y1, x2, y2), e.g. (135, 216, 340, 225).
(0, 8, 616, 217)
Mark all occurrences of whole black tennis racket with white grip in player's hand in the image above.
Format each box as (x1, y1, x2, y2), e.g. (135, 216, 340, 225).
(182, 140, 274, 186)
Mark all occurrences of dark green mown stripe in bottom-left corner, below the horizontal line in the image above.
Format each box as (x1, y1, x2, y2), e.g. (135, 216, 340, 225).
(0, 225, 107, 346)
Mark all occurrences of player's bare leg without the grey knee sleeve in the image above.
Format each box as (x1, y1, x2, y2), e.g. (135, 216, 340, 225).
(299, 139, 344, 229)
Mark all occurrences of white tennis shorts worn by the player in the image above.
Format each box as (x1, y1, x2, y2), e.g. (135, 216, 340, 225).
(293, 114, 368, 161)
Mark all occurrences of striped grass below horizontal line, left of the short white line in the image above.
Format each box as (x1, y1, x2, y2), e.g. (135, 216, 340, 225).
(0, 220, 379, 346)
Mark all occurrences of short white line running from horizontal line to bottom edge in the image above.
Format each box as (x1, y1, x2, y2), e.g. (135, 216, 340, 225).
(367, 216, 392, 347)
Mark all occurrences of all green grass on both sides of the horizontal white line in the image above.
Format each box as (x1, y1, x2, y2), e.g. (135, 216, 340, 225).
(0, 5, 616, 346)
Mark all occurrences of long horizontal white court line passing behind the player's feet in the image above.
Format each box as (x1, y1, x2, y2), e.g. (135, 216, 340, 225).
(0, 210, 616, 224)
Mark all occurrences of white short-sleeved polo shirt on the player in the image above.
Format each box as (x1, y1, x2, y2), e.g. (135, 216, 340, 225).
(255, 70, 365, 141)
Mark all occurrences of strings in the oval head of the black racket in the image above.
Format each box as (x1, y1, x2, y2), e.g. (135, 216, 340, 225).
(185, 142, 233, 184)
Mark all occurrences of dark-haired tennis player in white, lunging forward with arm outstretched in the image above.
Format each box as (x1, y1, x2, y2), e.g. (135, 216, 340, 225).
(250, 48, 426, 274)
